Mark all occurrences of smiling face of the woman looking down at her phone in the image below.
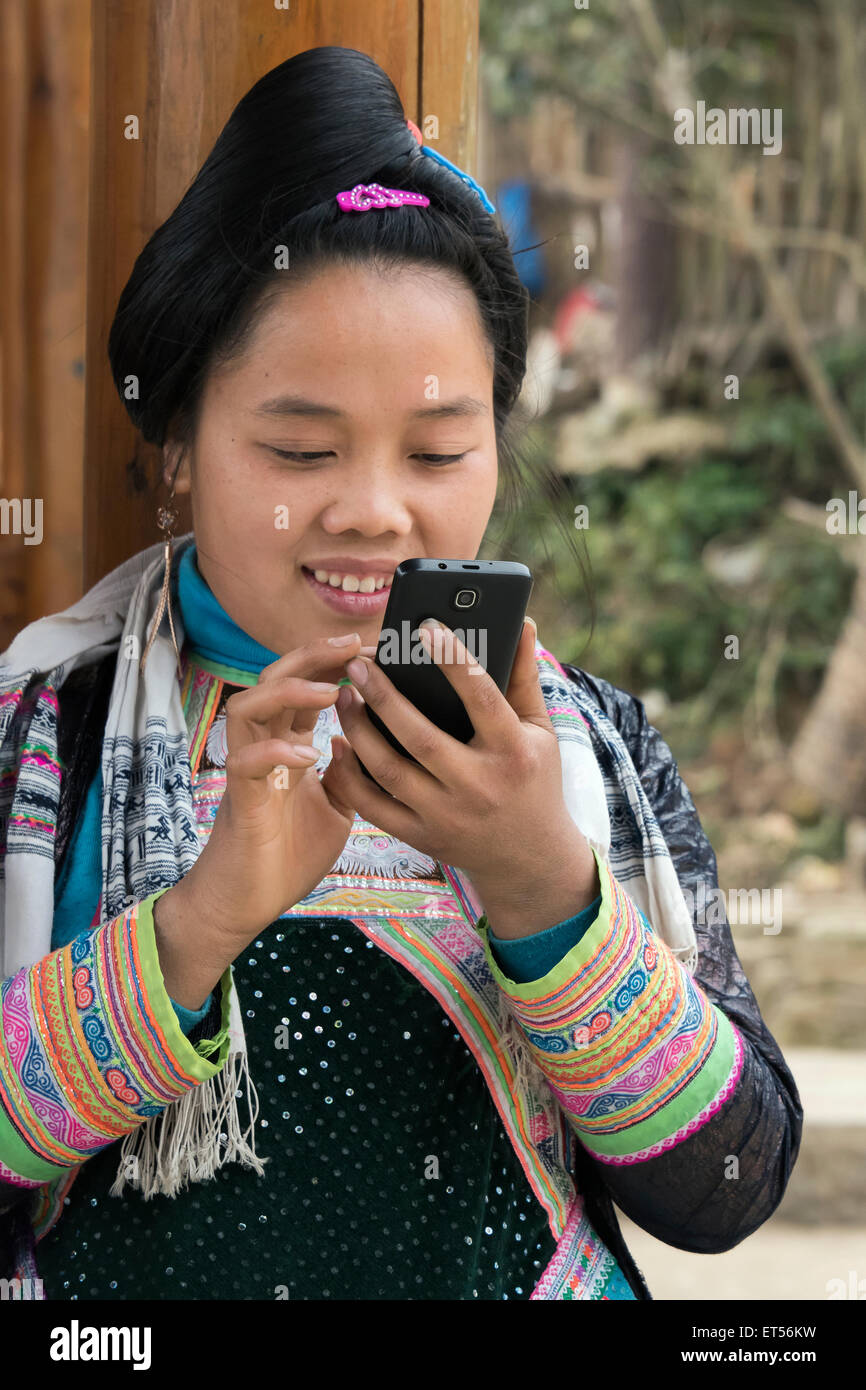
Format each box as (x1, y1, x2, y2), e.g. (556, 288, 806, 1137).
(164, 265, 498, 656)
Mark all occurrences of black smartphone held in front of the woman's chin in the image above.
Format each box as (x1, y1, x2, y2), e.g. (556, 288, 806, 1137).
(359, 557, 532, 780)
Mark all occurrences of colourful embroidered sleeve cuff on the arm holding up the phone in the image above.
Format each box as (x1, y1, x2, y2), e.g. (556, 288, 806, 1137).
(478, 855, 742, 1163)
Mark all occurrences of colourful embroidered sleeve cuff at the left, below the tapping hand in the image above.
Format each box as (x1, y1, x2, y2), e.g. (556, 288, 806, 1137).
(0, 890, 231, 1187)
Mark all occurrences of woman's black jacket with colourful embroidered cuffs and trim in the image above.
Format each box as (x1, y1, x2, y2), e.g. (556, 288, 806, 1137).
(0, 644, 802, 1298)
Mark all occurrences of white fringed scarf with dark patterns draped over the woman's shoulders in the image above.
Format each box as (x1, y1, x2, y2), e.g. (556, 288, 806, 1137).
(0, 532, 696, 1198)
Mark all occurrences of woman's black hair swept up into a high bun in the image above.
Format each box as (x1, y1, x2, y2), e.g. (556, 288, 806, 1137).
(108, 46, 584, 636)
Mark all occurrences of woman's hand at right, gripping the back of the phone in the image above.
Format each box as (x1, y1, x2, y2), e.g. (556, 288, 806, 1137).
(325, 621, 599, 937)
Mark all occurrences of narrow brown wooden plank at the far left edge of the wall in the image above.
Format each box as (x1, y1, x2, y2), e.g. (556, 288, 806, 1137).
(0, 0, 90, 639)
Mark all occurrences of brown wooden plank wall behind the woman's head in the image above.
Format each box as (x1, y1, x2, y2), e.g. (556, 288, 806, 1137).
(0, 0, 478, 649)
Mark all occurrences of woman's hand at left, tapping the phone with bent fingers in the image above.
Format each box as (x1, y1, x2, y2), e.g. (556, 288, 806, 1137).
(180, 632, 363, 954)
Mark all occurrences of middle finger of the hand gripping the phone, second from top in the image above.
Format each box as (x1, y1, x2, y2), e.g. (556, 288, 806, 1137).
(336, 656, 466, 783)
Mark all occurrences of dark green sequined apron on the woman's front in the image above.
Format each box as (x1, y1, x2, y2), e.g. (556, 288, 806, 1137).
(36, 917, 556, 1300)
